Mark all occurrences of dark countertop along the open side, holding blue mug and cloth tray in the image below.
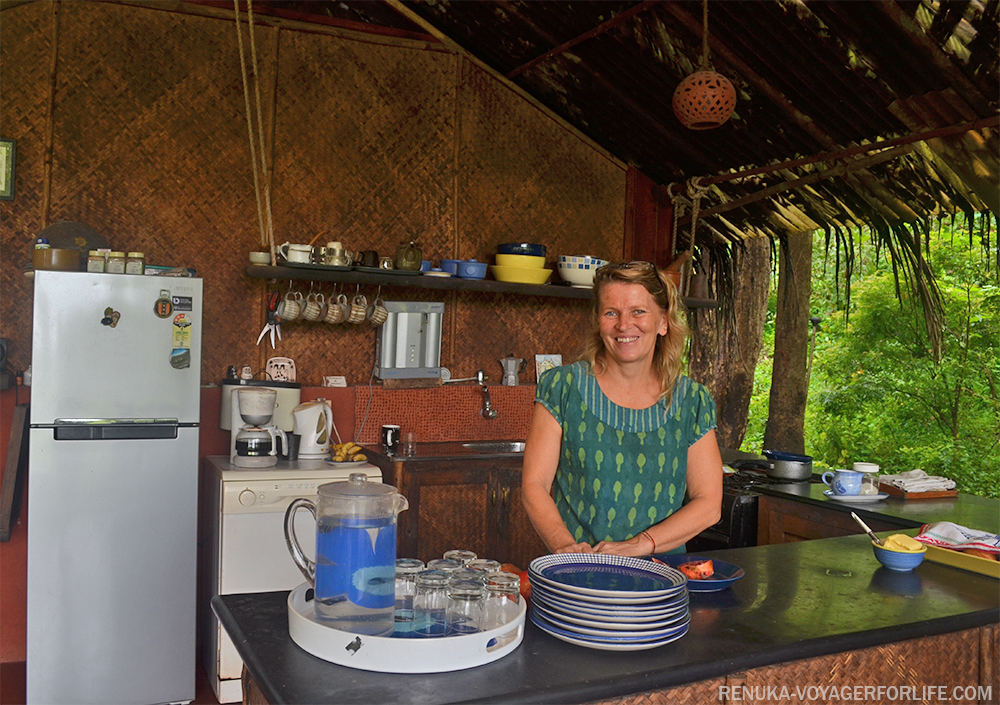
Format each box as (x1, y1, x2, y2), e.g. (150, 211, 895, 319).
(754, 483, 1000, 534)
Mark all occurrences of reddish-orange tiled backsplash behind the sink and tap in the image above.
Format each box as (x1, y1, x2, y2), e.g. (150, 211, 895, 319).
(354, 385, 535, 443)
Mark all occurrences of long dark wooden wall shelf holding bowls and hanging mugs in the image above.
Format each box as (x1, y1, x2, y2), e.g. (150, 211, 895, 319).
(246, 265, 718, 308)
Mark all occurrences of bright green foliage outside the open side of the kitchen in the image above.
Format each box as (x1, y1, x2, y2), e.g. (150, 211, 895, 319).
(743, 217, 1000, 497)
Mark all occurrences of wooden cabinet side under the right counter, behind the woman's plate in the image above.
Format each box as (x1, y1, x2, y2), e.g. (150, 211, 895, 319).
(757, 495, 903, 546)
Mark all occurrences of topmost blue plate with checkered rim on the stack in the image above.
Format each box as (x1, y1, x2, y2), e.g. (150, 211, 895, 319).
(528, 553, 687, 603)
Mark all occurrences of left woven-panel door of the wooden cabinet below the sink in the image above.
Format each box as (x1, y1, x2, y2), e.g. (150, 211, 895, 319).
(399, 462, 496, 562)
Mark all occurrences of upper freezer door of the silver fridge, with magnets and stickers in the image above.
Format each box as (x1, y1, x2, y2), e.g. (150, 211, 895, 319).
(31, 271, 202, 424)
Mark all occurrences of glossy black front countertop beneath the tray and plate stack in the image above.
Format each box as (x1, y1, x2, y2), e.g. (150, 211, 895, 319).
(212, 535, 1000, 704)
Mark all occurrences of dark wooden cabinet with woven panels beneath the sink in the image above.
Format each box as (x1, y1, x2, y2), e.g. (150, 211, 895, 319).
(372, 455, 548, 568)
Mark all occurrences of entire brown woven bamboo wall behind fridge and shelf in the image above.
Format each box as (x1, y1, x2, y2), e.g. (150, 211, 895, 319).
(0, 2, 625, 385)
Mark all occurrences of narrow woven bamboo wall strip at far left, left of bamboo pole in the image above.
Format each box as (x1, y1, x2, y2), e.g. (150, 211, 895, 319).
(0, 3, 52, 370)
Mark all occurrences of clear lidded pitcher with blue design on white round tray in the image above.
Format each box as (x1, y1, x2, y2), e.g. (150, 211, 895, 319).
(285, 472, 409, 636)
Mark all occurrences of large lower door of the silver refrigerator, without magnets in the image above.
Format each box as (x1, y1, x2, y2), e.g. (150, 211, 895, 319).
(27, 428, 198, 705)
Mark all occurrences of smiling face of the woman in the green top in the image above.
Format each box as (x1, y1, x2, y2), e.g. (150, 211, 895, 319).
(598, 282, 669, 365)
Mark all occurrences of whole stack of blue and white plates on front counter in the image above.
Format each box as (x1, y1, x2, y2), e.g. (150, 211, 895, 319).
(528, 553, 691, 651)
